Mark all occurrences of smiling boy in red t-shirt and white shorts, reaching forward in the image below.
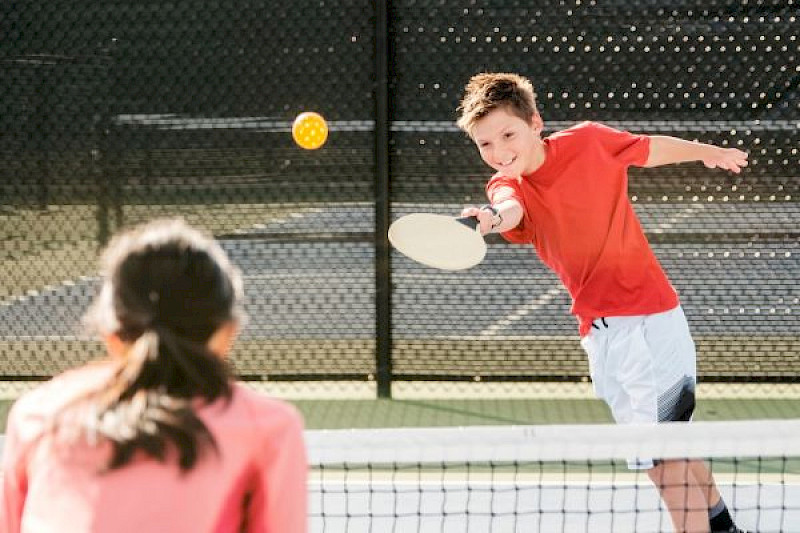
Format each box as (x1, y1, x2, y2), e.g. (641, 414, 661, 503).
(458, 73, 747, 533)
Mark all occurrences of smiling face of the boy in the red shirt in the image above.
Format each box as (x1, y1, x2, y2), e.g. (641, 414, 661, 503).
(472, 108, 544, 177)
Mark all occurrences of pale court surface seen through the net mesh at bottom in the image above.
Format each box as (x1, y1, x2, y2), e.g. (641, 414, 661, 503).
(311, 474, 800, 533)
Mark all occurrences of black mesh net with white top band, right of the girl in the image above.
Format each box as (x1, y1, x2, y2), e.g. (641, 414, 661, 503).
(306, 420, 800, 533)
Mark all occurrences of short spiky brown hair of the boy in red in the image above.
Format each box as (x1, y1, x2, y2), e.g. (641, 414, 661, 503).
(457, 72, 536, 134)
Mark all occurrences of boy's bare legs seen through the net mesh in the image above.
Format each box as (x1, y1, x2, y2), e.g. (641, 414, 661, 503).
(647, 460, 710, 533)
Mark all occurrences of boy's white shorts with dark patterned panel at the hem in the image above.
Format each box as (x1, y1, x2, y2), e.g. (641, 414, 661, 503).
(581, 305, 697, 468)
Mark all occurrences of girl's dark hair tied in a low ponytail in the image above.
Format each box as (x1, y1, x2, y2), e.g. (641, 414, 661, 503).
(75, 220, 242, 471)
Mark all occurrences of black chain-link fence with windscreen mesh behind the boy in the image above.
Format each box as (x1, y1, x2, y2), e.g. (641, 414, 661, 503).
(0, 0, 800, 391)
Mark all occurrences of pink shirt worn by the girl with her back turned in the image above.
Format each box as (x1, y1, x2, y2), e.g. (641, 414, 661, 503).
(0, 364, 307, 533)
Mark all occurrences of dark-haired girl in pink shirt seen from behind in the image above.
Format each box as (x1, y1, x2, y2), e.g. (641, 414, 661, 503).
(0, 221, 307, 533)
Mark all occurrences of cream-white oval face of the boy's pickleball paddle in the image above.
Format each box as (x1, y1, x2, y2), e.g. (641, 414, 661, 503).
(389, 213, 486, 270)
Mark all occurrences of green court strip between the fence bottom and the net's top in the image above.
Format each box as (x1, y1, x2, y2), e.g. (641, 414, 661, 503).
(0, 398, 800, 430)
